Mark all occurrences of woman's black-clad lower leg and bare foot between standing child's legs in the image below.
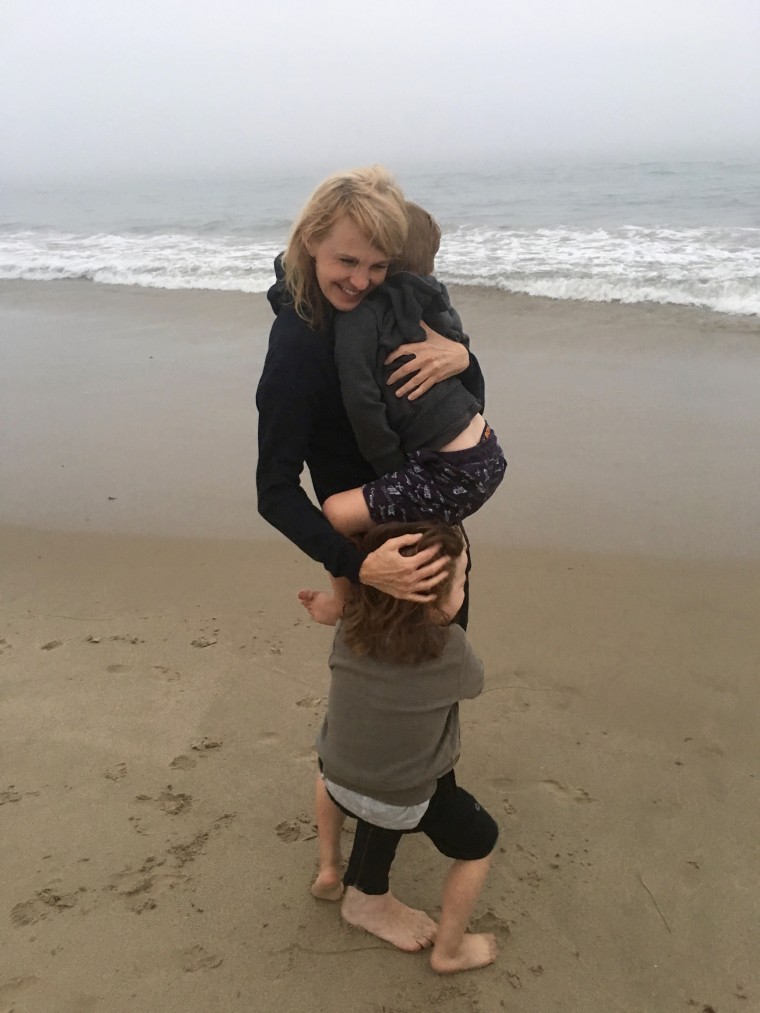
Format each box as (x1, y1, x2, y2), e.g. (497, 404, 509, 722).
(340, 820, 436, 953)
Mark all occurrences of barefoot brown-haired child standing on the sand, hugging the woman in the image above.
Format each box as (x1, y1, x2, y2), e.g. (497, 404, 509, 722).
(312, 522, 499, 973)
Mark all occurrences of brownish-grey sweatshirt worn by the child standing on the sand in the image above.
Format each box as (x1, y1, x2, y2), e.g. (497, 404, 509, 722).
(316, 624, 483, 805)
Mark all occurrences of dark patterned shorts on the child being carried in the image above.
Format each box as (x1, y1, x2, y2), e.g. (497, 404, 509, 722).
(362, 425, 507, 524)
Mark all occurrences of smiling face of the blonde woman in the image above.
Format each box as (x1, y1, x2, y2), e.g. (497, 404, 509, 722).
(306, 218, 390, 313)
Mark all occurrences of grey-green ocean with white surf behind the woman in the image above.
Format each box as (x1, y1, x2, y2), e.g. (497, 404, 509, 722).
(0, 161, 760, 315)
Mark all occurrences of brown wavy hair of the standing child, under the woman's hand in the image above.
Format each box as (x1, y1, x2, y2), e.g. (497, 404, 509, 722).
(343, 521, 465, 665)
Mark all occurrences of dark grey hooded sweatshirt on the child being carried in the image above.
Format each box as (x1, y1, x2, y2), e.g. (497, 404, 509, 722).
(335, 271, 483, 475)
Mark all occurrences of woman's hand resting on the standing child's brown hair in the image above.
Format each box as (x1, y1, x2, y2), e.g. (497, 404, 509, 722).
(359, 532, 449, 602)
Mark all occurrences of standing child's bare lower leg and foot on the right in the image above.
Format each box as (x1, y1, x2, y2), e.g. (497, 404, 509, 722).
(430, 855, 497, 975)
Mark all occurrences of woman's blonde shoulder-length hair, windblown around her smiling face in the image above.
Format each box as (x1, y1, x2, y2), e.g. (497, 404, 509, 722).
(284, 165, 407, 330)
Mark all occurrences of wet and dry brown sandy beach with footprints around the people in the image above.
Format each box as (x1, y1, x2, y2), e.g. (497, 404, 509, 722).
(0, 282, 760, 1013)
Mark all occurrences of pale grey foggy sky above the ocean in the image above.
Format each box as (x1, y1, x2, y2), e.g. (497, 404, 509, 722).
(0, 0, 760, 177)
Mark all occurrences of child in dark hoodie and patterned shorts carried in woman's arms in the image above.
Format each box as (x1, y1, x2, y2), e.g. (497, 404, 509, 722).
(299, 202, 507, 625)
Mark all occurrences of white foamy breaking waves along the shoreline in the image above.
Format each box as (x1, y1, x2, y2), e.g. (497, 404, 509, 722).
(0, 223, 760, 315)
